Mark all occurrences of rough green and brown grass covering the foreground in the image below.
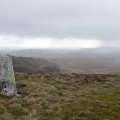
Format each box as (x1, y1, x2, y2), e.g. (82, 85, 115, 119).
(0, 74, 120, 120)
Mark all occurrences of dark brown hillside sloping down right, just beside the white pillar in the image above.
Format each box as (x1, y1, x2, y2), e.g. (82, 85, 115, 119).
(12, 57, 60, 74)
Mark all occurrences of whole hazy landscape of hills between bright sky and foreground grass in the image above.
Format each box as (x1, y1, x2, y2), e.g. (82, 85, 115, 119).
(8, 48, 120, 74)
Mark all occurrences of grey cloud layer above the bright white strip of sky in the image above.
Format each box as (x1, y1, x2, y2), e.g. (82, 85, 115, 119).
(0, 0, 120, 40)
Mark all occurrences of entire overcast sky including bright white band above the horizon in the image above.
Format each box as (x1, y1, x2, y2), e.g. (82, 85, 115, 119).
(0, 0, 120, 48)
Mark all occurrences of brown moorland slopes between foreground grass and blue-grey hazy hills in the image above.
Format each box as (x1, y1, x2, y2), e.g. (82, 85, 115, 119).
(12, 57, 120, 74)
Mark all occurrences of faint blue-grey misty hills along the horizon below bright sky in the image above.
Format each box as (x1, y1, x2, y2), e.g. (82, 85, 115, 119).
(7, 48, 120, 59)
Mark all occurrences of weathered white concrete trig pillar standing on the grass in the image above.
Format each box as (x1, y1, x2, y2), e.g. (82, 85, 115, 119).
(0, 54, 17, 96)
